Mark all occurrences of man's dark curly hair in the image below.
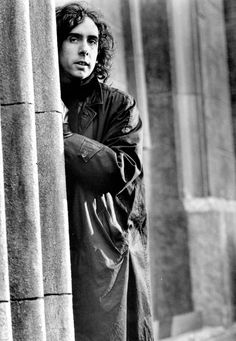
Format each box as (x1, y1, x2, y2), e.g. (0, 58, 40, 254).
(56, 2, 114, 82)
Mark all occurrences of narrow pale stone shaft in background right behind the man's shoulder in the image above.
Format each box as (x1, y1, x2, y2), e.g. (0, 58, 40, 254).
(121, 0, 151, 209)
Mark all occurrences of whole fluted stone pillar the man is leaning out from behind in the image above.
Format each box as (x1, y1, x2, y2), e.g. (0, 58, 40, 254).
(0, 0, 74, 341)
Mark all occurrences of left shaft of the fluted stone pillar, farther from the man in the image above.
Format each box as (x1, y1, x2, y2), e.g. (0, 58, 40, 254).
(0, 0, 46, 341)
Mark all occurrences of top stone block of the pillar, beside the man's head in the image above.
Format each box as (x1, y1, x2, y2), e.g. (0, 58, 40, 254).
(30, 0, 61, 112)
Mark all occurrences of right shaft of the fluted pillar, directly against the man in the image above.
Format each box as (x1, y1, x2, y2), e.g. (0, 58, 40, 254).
(30, 0, 74, 341)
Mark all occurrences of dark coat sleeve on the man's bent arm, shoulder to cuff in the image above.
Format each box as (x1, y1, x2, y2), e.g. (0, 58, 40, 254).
(64, 96, 142, 194)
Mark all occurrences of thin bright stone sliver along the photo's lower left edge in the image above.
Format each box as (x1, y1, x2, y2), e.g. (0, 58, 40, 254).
(0, 107, 12, 341)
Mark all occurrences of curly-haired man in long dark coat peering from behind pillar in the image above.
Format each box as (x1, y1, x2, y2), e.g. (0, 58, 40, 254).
(56, 3, 153, 341)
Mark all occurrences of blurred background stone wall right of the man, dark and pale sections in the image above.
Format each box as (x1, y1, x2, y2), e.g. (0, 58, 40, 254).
(141, 0, 236, 338)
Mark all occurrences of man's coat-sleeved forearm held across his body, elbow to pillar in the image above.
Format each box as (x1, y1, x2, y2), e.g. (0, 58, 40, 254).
(64, 134, 141, 193)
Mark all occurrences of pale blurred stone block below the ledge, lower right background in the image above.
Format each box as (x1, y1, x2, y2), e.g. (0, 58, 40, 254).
(185, 199, 233, 325)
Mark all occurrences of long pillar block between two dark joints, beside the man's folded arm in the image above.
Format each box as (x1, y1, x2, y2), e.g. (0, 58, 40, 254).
(36, 112, 71, 294)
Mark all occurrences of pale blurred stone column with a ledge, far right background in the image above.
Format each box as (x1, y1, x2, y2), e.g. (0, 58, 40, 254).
(169, 0, 236, 325)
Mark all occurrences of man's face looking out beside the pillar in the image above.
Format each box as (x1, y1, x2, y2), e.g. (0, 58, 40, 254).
(59, 17, 99, 82)
